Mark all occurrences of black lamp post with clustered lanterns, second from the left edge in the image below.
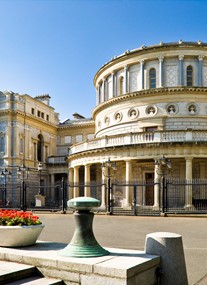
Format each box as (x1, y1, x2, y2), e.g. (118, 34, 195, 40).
(17, 164, 30, 212)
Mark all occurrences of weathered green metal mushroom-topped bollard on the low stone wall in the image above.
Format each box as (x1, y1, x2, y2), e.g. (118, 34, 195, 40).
(60, 197, 110, 258)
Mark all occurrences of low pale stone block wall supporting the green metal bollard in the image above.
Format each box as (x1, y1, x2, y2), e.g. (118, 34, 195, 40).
(0, 241, 160, 285)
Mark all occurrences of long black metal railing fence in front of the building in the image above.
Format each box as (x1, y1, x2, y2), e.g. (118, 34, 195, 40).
(0, 177, 207, 215)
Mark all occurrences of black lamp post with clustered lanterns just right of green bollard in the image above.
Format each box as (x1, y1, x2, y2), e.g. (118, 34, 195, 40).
(101, 158, 117, 215)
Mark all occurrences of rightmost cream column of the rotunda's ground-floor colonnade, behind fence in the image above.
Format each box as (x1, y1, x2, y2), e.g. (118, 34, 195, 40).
(185, 157, 193, 208)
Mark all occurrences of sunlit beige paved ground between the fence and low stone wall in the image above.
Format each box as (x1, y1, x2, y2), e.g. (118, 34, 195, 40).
(38, 214, 207, 285)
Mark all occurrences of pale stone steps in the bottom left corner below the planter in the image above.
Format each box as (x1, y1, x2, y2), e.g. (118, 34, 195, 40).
(0, 261, 62, 285)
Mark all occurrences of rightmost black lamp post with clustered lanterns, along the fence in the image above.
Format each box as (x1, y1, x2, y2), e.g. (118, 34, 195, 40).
(155, 155, 172, 213)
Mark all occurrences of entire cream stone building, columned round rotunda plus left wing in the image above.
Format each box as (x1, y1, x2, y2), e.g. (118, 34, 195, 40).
(0, 41, 207, 209)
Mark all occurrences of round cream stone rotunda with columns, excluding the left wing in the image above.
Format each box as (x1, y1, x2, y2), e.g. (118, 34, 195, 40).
(68, 41, 207, 208)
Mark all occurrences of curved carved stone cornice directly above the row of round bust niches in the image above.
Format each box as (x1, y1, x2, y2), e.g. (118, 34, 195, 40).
(92, 86, 207, 117)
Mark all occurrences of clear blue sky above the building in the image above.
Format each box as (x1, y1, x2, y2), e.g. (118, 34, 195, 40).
(0, 0, 207, 120)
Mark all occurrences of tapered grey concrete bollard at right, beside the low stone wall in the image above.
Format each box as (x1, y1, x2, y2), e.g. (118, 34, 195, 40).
(145, 232, 188, 285)
